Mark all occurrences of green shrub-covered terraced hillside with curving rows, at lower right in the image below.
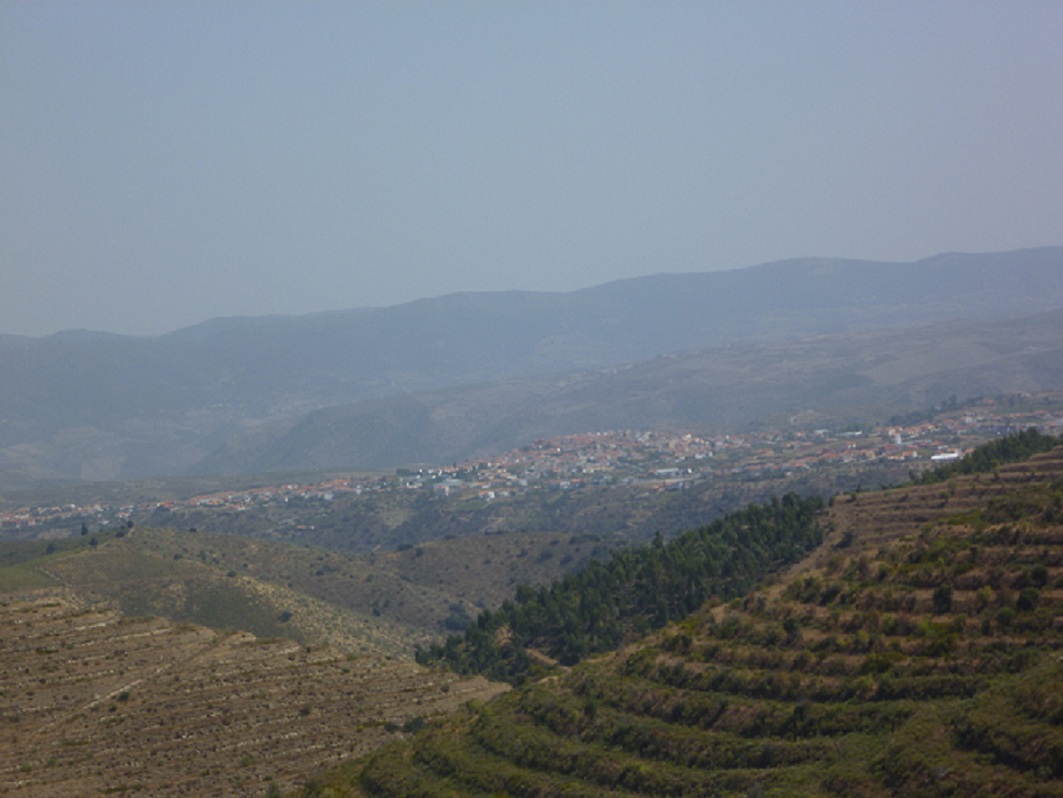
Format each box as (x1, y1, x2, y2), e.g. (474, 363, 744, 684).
(342, 448, 1063, 797)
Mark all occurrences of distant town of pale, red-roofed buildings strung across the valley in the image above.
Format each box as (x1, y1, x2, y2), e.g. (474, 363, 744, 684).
(0, 392, 1063, 533)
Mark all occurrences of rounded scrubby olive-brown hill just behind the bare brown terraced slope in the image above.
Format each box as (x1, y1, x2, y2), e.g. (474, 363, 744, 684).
(0, 527, 606, 656)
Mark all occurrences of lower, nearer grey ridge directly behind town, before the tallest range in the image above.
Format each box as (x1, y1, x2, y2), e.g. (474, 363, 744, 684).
(200, 311, 1063, 474)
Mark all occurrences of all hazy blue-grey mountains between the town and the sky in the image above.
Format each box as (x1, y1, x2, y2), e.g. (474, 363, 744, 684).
(0, 247, 1063, 487)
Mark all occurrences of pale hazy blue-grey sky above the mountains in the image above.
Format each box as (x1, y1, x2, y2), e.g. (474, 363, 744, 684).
(0, 0, 1063, 335)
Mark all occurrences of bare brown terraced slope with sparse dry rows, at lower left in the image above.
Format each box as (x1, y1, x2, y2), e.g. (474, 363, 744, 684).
(0, 596, 501, 798)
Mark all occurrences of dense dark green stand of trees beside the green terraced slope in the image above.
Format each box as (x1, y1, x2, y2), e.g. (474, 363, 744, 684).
(417, 493, 824, 684)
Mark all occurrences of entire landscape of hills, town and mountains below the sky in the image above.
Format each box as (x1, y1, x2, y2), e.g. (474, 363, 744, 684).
(0, 248, 1063, 798)
